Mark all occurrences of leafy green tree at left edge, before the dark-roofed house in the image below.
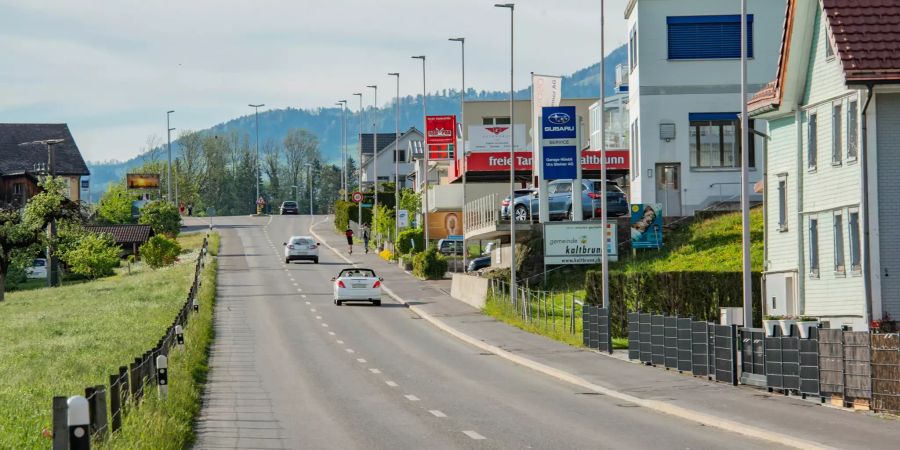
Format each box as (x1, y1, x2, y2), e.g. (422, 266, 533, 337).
(0, 177, 78, 301)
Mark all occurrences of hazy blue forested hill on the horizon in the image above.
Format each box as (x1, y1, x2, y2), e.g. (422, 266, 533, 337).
(88, 46, 627, 192)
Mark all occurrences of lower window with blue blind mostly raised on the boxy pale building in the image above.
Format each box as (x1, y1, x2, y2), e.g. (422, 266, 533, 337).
(688, 113, 755, 169)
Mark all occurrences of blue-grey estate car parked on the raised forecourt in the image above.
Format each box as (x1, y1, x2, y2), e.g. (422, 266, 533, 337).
(500, 180, 628, 221)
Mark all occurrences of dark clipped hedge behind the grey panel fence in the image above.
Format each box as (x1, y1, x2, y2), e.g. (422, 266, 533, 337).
(584, 270, 762, 337)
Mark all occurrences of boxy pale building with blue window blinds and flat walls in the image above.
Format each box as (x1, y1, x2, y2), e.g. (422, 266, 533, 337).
(625, 0, 785, 216)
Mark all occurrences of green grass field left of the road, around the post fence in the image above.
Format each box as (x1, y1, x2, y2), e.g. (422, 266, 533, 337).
(0, 230, 217, 448)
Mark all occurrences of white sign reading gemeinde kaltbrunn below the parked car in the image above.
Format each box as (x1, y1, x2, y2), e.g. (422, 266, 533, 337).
(544, 221, 619, 265)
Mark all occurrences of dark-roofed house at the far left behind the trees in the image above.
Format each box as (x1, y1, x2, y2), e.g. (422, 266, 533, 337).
(0, 123, 90, 207)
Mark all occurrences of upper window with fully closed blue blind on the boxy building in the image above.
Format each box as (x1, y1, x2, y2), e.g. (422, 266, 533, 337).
(666, 14, 753, 60)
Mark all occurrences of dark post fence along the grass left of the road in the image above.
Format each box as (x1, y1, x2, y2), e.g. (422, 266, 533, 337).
(53, 236, 208, 450)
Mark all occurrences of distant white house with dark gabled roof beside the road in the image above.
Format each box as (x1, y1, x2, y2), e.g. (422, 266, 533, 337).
(359, 127, 423, 187)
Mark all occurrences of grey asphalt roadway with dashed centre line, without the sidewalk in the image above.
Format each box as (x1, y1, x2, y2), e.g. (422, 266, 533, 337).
(197, 216, 784, 449)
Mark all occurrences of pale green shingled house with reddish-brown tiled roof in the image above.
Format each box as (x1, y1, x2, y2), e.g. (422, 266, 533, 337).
(748, 0, 900, 330)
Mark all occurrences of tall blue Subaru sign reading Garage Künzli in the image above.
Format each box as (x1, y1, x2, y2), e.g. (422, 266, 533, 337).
(541, 106, 578, 180)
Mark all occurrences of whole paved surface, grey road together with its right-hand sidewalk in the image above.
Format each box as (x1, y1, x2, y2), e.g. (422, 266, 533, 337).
(187, 216, 900, 449)
